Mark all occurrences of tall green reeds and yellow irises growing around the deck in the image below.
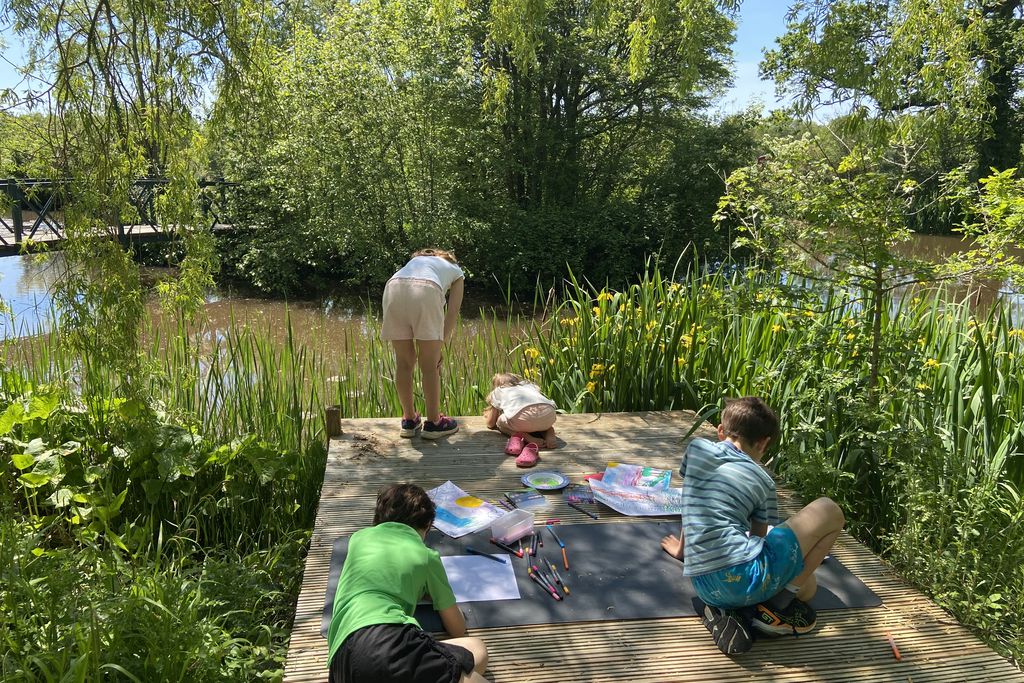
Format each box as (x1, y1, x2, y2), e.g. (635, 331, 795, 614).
(2, 268, 1024, 671)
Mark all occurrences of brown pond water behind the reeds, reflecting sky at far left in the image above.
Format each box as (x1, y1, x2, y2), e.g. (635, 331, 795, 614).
(0, 236, 1024, 343)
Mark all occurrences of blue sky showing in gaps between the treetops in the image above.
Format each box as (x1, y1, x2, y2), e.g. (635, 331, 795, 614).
(0, 0, 788, 112)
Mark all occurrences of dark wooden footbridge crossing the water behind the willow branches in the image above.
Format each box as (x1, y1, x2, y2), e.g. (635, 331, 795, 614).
(0, 178, 236, 256)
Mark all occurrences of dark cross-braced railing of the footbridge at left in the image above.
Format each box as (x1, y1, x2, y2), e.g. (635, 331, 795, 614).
(0, 178, 238, 247)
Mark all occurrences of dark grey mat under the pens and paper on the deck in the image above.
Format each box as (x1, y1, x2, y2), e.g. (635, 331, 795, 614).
(322, 520, 882, 636)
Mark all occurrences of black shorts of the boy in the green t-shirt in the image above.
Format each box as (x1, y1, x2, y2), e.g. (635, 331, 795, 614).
(330, 624, 474, 683)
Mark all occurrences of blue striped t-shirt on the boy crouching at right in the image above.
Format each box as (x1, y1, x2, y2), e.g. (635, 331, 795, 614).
(679, 438, 778, 577)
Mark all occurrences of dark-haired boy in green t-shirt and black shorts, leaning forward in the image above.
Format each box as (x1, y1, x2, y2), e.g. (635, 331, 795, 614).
(328, 483, 487, 683)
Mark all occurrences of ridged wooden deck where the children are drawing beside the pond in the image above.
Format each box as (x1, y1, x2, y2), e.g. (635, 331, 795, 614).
(285, 412, 1024, 683)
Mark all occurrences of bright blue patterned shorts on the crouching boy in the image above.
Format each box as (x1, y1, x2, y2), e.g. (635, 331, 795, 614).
(691, 526, 804, 607)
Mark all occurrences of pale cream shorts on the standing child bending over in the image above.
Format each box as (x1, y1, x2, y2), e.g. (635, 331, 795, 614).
(381, 278, 444, 341)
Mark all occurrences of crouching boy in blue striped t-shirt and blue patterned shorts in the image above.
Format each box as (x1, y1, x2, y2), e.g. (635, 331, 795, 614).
(662, 396, 846, 654)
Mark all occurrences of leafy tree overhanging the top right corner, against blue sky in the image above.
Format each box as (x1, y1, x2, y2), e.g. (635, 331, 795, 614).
(762, 0, 1024, 191)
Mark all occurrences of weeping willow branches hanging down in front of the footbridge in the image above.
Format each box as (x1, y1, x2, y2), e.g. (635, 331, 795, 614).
(0, 0, 268, 393)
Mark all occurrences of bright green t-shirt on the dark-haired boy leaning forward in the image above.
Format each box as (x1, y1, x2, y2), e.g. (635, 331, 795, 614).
(327, 522, 455, 661)
